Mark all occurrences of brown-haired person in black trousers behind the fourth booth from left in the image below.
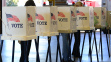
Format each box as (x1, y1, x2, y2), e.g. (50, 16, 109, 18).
(72, 2, 83, 58)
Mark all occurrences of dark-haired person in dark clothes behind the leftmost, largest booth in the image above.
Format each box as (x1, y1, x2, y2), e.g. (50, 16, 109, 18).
(20, 0, 36, 62)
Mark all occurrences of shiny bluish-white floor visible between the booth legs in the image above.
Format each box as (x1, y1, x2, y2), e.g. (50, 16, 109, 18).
(2, 32, 111, 62)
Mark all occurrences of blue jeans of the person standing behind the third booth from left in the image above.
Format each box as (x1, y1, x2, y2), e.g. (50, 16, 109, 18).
(61, 33, 69, 61)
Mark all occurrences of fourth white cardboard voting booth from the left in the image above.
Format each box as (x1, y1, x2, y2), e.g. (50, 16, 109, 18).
(76, 7, 95, 30)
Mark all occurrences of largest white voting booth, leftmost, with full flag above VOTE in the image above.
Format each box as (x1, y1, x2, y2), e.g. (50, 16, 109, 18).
(1, 6, 37, 40)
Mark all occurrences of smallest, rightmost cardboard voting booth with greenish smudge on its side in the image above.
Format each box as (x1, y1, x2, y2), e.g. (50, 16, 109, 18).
(94, 7, 106, 28)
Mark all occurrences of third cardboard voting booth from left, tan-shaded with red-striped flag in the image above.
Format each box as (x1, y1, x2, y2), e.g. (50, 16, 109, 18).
(58, 6, 76, 33)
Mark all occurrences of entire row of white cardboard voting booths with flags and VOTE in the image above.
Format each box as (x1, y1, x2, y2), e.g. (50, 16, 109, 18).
(1, 6, 107, 40)
